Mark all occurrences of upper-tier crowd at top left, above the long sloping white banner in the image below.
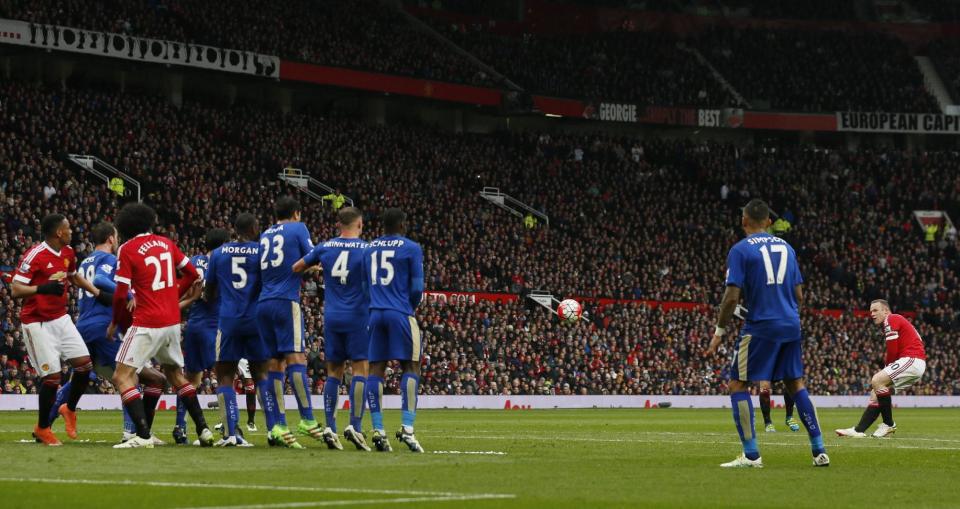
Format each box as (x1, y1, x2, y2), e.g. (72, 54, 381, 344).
(0, 0, 494, 86)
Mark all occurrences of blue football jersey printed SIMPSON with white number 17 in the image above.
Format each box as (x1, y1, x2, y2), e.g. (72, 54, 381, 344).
(727, 233, 803, 341)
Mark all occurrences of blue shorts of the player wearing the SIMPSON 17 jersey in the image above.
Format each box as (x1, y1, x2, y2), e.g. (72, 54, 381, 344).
(729, 334, 803, 382)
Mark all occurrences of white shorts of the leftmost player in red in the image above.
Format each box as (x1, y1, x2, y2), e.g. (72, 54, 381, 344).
(20, 315, 90, 377)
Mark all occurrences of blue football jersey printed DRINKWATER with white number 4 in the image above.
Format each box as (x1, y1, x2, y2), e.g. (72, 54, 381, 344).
(304, 237, 370, 322)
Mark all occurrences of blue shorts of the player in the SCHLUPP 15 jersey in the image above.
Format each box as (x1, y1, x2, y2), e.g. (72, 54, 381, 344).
(369, 309, 423, 362)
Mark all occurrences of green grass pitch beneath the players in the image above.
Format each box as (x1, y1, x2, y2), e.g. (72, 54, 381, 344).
(0, 409, 960, 509)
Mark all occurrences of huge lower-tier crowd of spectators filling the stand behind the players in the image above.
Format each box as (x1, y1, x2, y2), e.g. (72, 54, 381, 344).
(0, 81, 960, 394)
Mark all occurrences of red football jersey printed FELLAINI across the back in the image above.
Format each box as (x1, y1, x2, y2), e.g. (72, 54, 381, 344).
(114, 233, 190, 329)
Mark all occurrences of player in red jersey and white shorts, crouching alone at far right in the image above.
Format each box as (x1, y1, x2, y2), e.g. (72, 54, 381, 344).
(837, 299, 927, 438)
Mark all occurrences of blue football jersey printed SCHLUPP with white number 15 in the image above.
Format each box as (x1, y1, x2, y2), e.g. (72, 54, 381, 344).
(363, 235, 423, 316)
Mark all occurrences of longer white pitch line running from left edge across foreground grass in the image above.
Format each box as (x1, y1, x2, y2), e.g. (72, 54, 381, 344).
(0, 477, 516, 498)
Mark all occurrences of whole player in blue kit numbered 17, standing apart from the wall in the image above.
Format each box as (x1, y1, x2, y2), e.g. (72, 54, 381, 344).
(705, 199, 830, 468)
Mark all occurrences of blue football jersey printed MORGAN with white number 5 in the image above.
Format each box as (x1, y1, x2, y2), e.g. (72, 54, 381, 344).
(207, 242, 260, 320)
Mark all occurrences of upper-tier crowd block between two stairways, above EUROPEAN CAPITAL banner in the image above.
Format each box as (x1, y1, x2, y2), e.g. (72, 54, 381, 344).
(694, 28, 940, 113)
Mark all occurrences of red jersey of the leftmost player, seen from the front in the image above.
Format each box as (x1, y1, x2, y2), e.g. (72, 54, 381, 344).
(13, 242, 77, 323)
